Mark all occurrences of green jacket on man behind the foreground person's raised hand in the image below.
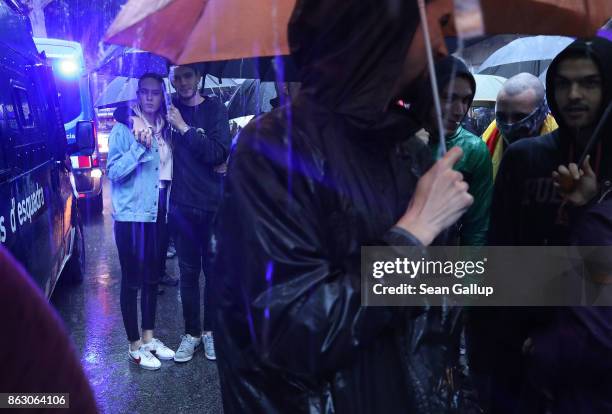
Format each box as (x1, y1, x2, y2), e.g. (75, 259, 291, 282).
(429, 127, 493, 246)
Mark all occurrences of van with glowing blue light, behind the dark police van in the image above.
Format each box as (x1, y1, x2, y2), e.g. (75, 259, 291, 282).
(34, 37, 103, 212)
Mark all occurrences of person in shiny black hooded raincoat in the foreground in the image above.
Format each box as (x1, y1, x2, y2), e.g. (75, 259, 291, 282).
(213, 0, 472, 414)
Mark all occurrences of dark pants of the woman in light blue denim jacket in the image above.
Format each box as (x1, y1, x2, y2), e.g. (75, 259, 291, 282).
(115, 190, 166, 342)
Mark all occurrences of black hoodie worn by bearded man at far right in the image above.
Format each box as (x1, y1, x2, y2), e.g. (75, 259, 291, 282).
(489, 38, 612, 246)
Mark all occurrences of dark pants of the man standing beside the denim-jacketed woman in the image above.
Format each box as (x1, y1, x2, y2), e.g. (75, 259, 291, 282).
(171, 206, 215, 337)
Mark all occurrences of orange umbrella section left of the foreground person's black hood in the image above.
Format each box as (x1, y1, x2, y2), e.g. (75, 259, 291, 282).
(105, 0, 295, 64)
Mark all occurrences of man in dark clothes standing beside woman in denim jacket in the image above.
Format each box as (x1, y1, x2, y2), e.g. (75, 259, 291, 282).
(168, 65, 230, 362)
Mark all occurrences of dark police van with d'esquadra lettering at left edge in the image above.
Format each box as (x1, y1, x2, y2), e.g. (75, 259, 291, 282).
(0, 0, 95, 297)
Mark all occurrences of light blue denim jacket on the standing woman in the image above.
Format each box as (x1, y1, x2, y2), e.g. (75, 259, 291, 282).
(106, 122, 159, 223)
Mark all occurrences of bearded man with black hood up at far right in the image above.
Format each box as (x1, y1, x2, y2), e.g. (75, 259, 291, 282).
(470, 38, 612, 413)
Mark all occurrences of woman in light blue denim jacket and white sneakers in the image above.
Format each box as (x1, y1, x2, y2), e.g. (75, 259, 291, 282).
(107, 73, 174, 370)
